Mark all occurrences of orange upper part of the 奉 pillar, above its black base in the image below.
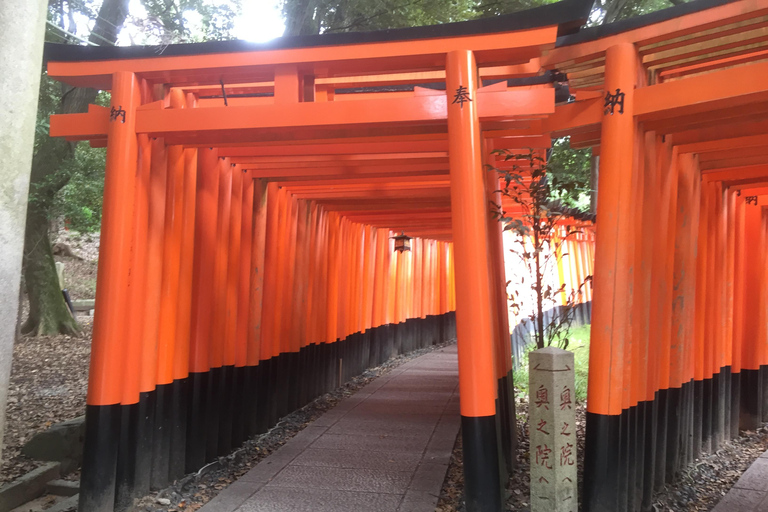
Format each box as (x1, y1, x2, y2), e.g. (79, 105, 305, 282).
(446, 51, 496, 417)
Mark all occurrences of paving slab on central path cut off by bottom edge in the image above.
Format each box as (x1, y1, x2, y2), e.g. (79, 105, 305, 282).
(238, 488, 401, 512)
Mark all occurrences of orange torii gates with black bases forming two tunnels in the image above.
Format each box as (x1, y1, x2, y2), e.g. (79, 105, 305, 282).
(46, 0, 768, 512)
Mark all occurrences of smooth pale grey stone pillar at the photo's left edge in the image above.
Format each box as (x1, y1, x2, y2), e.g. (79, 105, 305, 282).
(0, 0, 47, 464)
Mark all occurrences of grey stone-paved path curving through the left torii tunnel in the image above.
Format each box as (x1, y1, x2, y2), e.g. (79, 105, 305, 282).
(201, 345, 460, 512)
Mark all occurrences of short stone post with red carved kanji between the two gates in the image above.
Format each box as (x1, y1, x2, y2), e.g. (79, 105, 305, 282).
(528, 347, 578, 512)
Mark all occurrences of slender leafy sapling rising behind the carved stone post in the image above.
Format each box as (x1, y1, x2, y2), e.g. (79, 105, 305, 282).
(489, 150, 592, 348)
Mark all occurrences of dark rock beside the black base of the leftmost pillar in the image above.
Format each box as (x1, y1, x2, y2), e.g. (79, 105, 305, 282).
(21, 416, 85, 474)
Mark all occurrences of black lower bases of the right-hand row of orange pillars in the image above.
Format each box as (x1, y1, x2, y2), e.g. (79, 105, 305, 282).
(582, 366, 765, 512)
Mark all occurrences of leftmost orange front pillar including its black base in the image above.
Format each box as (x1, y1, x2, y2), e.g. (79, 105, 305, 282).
(79, 72, 141, 512)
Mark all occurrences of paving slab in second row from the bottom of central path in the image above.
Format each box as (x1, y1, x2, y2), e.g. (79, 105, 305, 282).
(265, 466, 411, 494)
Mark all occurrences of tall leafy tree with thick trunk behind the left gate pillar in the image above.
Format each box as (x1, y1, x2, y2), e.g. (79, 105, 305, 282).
(26, 0, 240, 335)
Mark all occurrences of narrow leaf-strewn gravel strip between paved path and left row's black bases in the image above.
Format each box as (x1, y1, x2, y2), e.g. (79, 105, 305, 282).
(133, 343, 450, 512)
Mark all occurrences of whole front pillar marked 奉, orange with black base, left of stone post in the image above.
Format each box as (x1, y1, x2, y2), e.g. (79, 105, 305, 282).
(446, 50, 502, 512)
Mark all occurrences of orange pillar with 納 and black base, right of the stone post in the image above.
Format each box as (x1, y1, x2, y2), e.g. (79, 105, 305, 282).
(583, 43, 638, 512)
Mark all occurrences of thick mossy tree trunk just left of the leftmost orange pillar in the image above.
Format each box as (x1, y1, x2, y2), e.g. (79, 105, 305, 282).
(21, 0, 129, 336)
